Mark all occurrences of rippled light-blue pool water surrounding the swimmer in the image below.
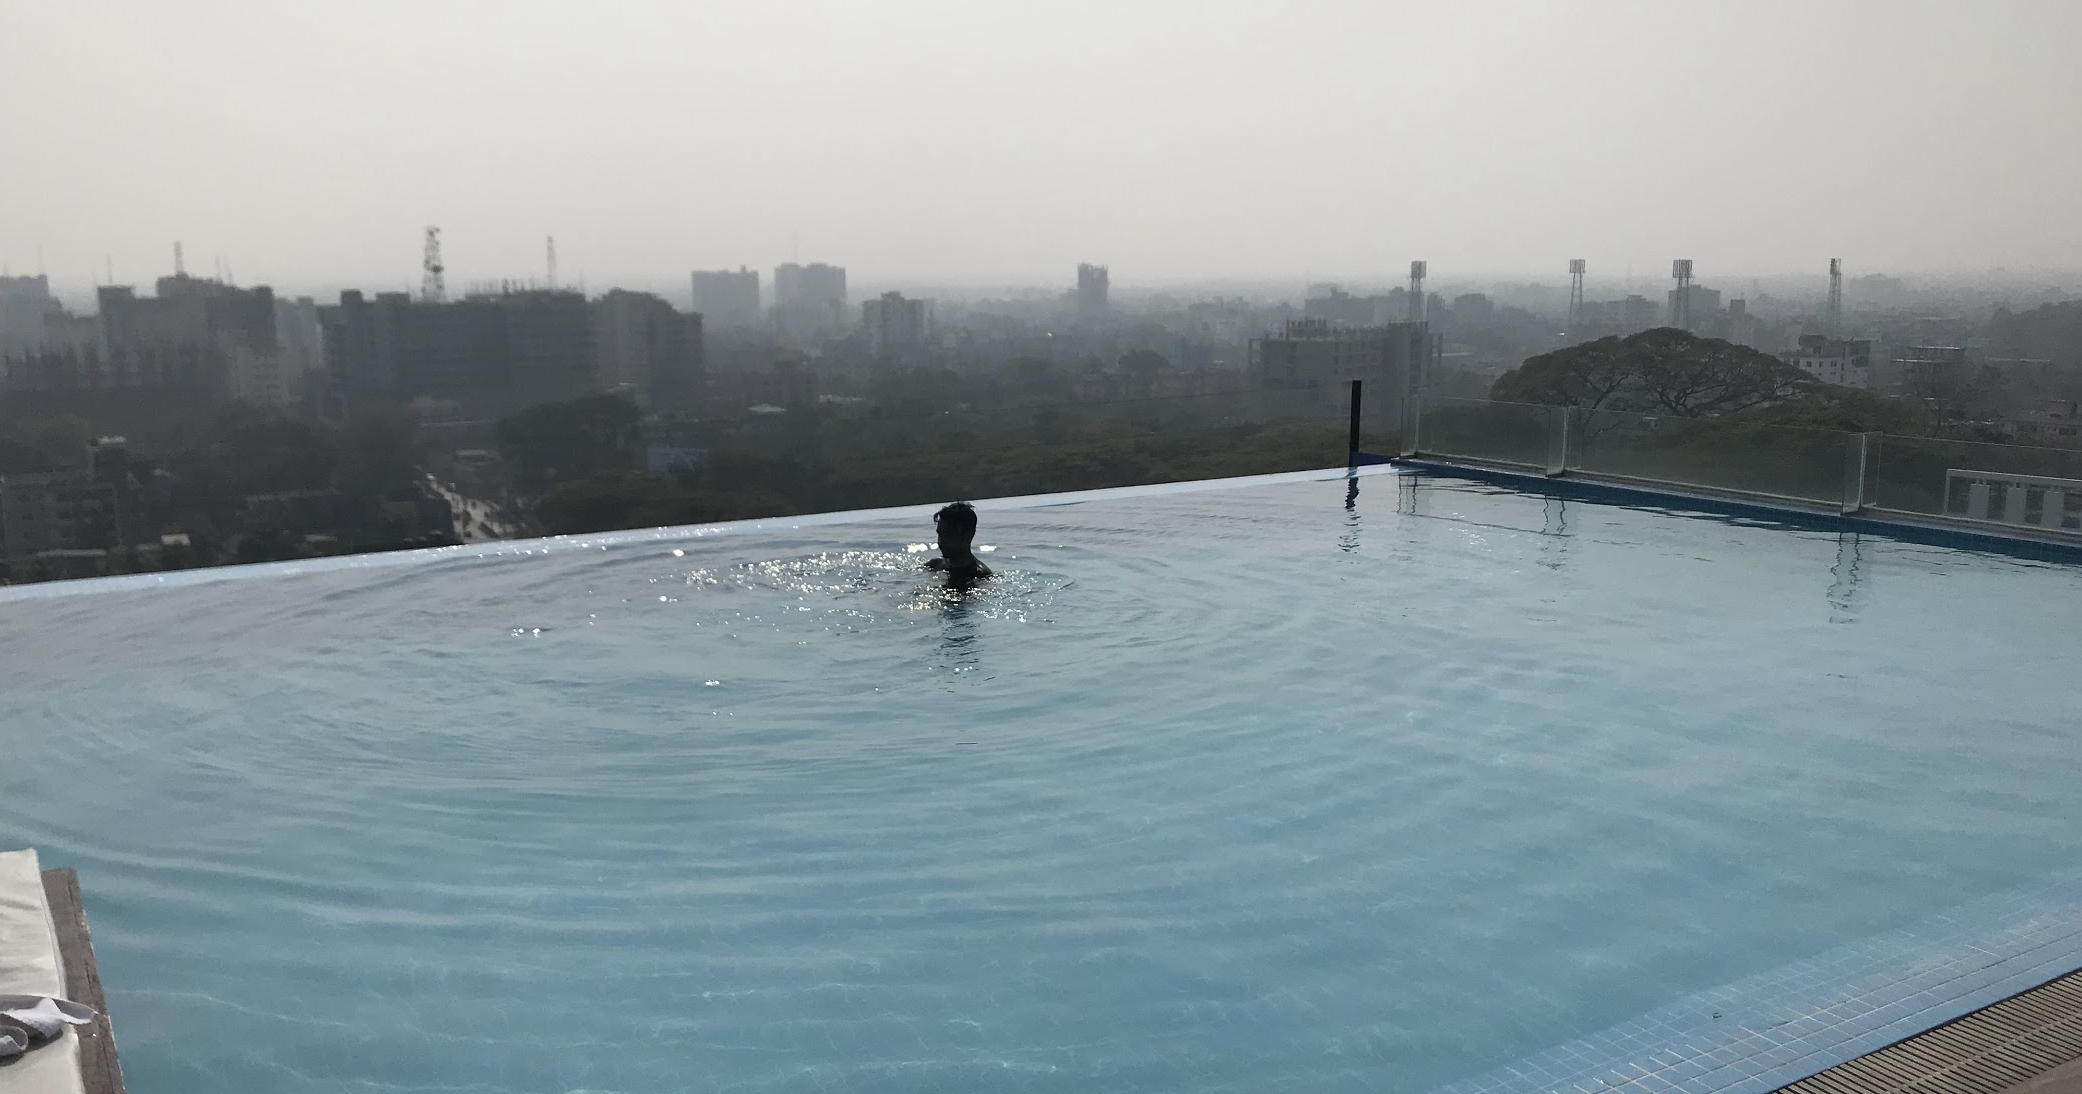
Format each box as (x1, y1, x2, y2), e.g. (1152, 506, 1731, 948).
(0, 475, 2082, 1092)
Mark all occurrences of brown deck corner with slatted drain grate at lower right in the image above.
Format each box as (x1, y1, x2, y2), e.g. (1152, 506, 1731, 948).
(1776, 973, 2082, 1094)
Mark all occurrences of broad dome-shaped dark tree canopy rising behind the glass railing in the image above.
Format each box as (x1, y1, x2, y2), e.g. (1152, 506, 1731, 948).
(1491, 327, 1832, 417)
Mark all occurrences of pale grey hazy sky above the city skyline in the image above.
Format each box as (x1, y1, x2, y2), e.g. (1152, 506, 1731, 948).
(0, 0, 2082, 288)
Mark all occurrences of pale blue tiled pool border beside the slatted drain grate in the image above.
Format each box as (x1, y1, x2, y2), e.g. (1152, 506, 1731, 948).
(1432, 873, 2082, 1094)
